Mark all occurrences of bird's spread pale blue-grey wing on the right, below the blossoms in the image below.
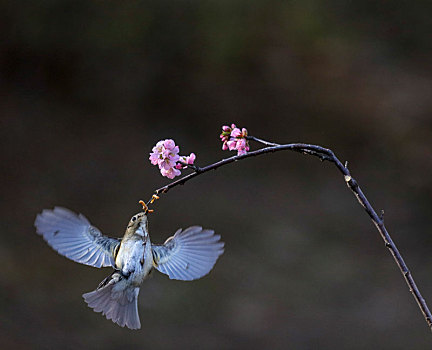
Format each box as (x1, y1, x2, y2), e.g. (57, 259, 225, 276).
(152, 226, 224, 281)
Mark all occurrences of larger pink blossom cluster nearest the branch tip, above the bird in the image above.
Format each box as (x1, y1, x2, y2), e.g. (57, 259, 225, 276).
(149, 139, 196, 179)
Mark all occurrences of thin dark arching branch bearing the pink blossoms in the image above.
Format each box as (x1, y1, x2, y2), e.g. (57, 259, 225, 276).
(147, 136, 432, 330)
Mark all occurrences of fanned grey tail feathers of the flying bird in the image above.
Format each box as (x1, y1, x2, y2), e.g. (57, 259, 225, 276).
(83, 272, 141, 329)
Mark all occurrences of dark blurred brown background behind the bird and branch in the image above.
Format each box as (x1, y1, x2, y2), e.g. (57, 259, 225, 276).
(0, 0, 432, 349)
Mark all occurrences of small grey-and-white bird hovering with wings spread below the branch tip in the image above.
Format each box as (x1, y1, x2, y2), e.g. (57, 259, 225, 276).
(34, 207, 225, 329)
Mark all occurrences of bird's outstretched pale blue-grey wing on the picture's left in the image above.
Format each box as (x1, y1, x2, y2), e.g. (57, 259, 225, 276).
(35, 207, 120, 267)
